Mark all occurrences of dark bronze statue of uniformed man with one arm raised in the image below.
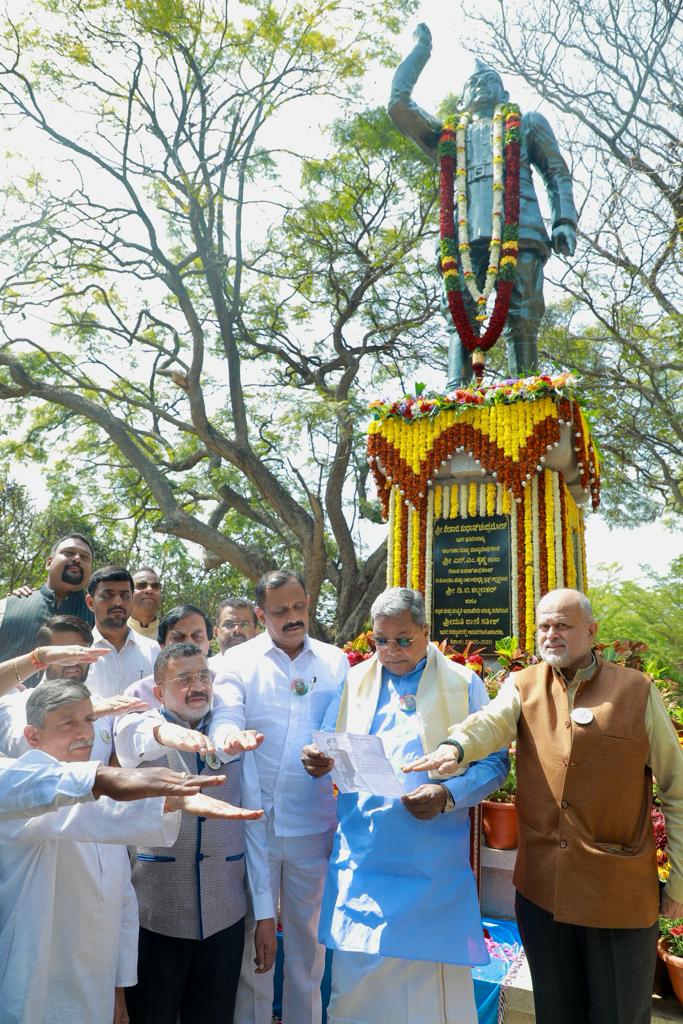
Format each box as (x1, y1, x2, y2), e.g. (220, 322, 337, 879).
(388, 25, 579, 388)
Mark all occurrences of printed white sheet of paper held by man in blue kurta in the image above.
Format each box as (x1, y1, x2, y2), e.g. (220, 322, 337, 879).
(313, 732, 405, 800)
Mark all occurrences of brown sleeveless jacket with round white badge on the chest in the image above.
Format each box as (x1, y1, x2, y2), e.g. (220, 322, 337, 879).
(513, 658, 659, 928)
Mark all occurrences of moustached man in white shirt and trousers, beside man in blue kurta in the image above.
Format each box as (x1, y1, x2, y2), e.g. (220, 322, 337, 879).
(218, 569, 348, 1024)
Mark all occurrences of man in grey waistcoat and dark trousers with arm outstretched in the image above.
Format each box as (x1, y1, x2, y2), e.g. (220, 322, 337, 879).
(117, 643, 275, 1024)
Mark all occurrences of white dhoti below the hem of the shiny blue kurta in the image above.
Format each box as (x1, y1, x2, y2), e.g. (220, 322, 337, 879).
(328, 949, 477, 1024)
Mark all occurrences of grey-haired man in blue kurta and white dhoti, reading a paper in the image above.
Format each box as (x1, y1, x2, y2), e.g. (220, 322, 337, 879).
(302, 587, 509, 1024)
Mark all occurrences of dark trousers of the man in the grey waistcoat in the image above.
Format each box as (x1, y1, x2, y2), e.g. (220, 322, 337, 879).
(126, 918, 245, 1024)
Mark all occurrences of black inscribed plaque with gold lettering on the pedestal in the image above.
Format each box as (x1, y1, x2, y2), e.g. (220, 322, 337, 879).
(431, 515, 512, 652)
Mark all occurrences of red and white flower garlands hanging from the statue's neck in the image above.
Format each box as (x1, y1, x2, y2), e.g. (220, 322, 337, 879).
(438, 103, 521, 380)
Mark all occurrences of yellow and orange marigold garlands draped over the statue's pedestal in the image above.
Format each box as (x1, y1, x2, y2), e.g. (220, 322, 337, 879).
(368, 374, 599, 650)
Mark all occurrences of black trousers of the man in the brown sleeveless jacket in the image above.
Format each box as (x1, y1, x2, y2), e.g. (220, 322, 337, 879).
(515, 893, 658, 1024)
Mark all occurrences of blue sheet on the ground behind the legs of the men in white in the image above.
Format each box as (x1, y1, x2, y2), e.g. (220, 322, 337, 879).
(272, 918, 521, 1024)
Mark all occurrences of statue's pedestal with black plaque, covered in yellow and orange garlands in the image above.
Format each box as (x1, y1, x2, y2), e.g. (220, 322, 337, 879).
(368, 375, 599, 651)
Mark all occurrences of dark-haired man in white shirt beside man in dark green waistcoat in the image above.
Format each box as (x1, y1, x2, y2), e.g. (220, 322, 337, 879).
(86, 565, 159, 697)
